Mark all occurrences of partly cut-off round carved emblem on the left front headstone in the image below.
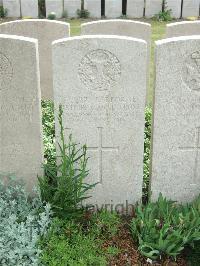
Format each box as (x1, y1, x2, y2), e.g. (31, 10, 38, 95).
(0, 52, 13, 90)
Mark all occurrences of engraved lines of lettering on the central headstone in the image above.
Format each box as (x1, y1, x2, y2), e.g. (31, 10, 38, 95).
(63, 96, 136, 122)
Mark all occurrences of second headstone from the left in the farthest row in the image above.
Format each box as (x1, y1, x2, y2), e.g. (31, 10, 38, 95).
(21, 0, 38, 18)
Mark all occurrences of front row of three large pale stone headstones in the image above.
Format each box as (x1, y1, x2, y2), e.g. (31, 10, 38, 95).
(0, 22, 200, 206)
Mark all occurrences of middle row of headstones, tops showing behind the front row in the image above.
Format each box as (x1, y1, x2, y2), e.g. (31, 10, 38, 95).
(0, 19, 200, 100)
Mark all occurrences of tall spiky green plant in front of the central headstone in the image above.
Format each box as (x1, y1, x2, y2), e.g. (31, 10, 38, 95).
(38, 106, 96, 218)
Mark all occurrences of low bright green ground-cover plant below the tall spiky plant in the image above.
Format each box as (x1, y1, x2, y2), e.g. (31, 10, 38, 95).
(41, 219, 107, 266)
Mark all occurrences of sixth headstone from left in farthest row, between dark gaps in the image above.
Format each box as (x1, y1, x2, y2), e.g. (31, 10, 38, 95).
(105, 0, 122, 18)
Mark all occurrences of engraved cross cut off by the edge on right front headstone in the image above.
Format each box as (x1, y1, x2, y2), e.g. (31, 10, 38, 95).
(180, 127, 200, 182)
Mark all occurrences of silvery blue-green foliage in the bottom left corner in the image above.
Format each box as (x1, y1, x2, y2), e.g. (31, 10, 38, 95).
(0, 178, 51, 266)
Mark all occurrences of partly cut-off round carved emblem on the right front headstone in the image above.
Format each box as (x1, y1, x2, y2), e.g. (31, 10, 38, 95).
(183, 51, 200, 91)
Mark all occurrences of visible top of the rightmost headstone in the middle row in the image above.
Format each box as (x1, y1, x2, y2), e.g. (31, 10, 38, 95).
(166, 21, 200, 38)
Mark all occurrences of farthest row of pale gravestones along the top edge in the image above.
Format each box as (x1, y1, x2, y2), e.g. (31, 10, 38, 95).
(0, 0, 200, 18)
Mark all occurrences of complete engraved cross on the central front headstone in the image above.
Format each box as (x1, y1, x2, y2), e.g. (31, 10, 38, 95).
(87, 127, 119, 184)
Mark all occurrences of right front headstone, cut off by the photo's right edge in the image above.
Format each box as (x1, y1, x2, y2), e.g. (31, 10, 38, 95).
(151, 36, 200, 202)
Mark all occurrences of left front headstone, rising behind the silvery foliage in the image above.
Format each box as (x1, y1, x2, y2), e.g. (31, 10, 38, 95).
(0, 35, 43, 189)
